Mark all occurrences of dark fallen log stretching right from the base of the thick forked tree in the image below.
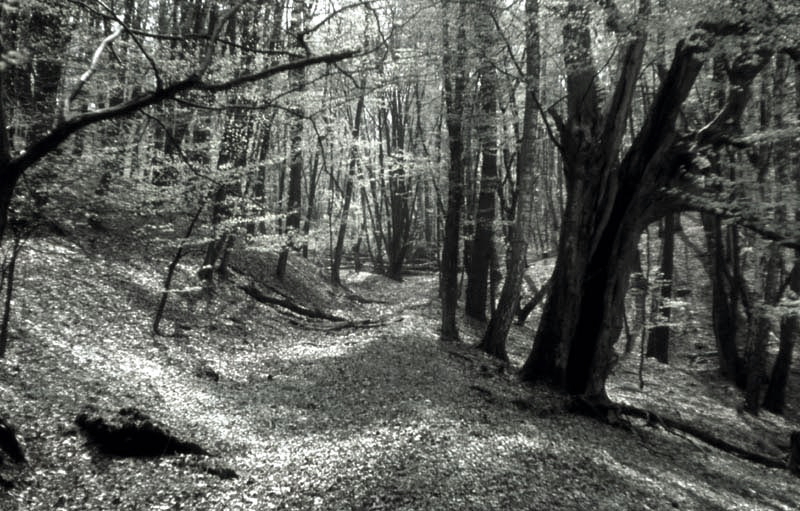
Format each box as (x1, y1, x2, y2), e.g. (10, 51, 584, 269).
(570, 398, 787, 469)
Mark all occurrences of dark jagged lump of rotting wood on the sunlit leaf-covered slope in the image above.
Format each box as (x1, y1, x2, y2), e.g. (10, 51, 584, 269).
(75, 408, 208, 458)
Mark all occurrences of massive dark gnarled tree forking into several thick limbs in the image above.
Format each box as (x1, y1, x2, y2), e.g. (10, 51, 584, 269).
(521, 0, 788, 402)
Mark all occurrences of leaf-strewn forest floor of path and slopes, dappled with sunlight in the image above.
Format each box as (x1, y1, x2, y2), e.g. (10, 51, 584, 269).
(0, 221, 800, 511)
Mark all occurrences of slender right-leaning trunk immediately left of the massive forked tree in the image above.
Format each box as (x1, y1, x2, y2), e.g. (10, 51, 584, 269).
(478, 0, 540, 360)
